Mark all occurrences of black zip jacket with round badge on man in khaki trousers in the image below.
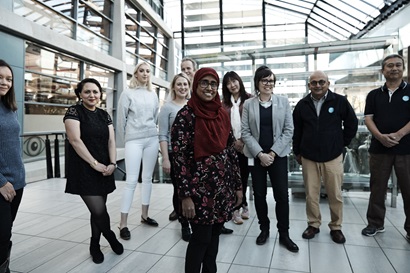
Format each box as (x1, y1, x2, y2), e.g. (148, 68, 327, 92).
(293, 90, 358, 162)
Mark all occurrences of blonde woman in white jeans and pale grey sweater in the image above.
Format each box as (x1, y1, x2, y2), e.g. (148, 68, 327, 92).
(117, 62, 159, 240)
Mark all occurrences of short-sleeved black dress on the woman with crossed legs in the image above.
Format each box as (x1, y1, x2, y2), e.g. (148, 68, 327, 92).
(64, 105, 115, 196)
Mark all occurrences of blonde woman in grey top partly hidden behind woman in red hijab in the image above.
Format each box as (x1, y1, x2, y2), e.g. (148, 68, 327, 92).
(158, 73, 191, 241)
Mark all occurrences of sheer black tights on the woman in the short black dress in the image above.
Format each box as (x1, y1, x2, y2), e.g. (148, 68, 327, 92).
(81, 195, 111, 240)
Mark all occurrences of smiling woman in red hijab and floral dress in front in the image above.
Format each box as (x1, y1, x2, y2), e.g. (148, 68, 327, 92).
(171, 68, 242, 273)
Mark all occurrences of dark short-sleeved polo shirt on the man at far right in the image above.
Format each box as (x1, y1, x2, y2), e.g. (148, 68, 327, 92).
(364, 81, 410, 155)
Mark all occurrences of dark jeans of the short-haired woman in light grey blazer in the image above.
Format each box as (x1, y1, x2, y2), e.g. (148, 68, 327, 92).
(251, 156, 289, 233)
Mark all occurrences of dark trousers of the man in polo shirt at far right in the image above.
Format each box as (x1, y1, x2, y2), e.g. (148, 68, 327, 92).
(367, 154, 410, 234)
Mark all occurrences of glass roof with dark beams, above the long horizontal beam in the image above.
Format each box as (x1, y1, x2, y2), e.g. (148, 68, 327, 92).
(164, 0, 410, 55)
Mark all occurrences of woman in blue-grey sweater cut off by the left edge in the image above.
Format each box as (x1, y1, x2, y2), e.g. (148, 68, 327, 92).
(0, 60, 26, 272)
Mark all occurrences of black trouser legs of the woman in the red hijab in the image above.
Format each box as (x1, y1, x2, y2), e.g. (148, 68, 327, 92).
(185, 223, 223, 273)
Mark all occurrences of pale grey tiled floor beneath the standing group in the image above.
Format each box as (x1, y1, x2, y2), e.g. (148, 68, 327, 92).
(11, 179, 410, 273)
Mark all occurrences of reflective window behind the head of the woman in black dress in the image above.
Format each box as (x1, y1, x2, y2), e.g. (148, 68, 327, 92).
(24, 43, 114, 115)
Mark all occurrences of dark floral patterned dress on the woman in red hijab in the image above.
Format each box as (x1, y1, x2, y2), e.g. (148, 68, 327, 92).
(171, 105, 242, 225)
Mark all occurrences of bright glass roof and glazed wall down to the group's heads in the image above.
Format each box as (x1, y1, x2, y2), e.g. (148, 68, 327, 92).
(163, 0, 410, 112)
